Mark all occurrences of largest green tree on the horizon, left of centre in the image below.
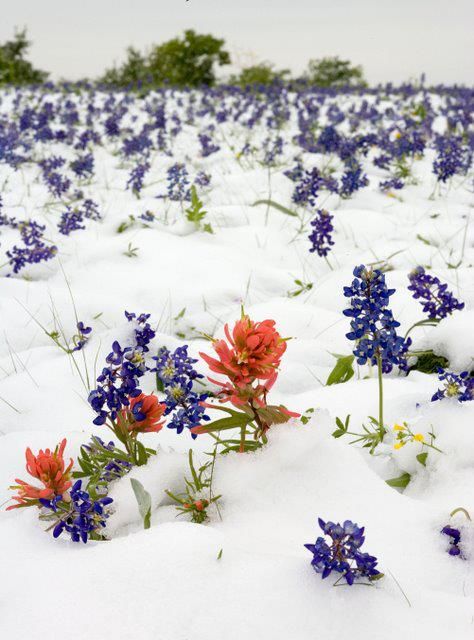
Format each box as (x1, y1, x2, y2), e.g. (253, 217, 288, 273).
(102, 29, 230, 87)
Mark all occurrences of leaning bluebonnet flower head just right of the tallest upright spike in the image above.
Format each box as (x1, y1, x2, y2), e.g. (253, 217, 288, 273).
(408, 267, 464, 320)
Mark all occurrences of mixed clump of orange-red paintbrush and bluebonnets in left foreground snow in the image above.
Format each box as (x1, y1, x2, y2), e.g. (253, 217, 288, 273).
(4, 312, 298, 542)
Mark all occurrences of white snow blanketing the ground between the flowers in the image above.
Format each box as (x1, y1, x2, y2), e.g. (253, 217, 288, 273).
(0, 86, 474, 640)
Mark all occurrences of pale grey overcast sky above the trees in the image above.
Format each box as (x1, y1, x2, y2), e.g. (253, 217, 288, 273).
(0, 0, 474, 84)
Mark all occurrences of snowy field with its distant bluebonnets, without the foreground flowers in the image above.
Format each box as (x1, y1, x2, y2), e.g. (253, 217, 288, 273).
(0, 89, 474, 640)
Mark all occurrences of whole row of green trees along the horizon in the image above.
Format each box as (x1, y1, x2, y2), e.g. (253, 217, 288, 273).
(0, 29, 366, 88)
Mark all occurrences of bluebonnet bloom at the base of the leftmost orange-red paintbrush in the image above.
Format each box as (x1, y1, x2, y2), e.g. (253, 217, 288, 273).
(40, 480, 113, 543)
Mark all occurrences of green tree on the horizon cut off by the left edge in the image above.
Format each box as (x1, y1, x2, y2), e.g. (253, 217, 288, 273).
(0, 29, 48, 85)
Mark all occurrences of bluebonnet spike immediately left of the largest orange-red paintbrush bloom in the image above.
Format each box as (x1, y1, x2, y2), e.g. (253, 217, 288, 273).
(154, 345, 209, 438)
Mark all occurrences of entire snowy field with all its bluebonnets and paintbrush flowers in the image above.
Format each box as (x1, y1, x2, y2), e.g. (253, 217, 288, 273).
(0, 72, 474, 640)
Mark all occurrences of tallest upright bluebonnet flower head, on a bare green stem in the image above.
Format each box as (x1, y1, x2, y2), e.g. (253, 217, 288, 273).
(343, 265, 411, 373)
